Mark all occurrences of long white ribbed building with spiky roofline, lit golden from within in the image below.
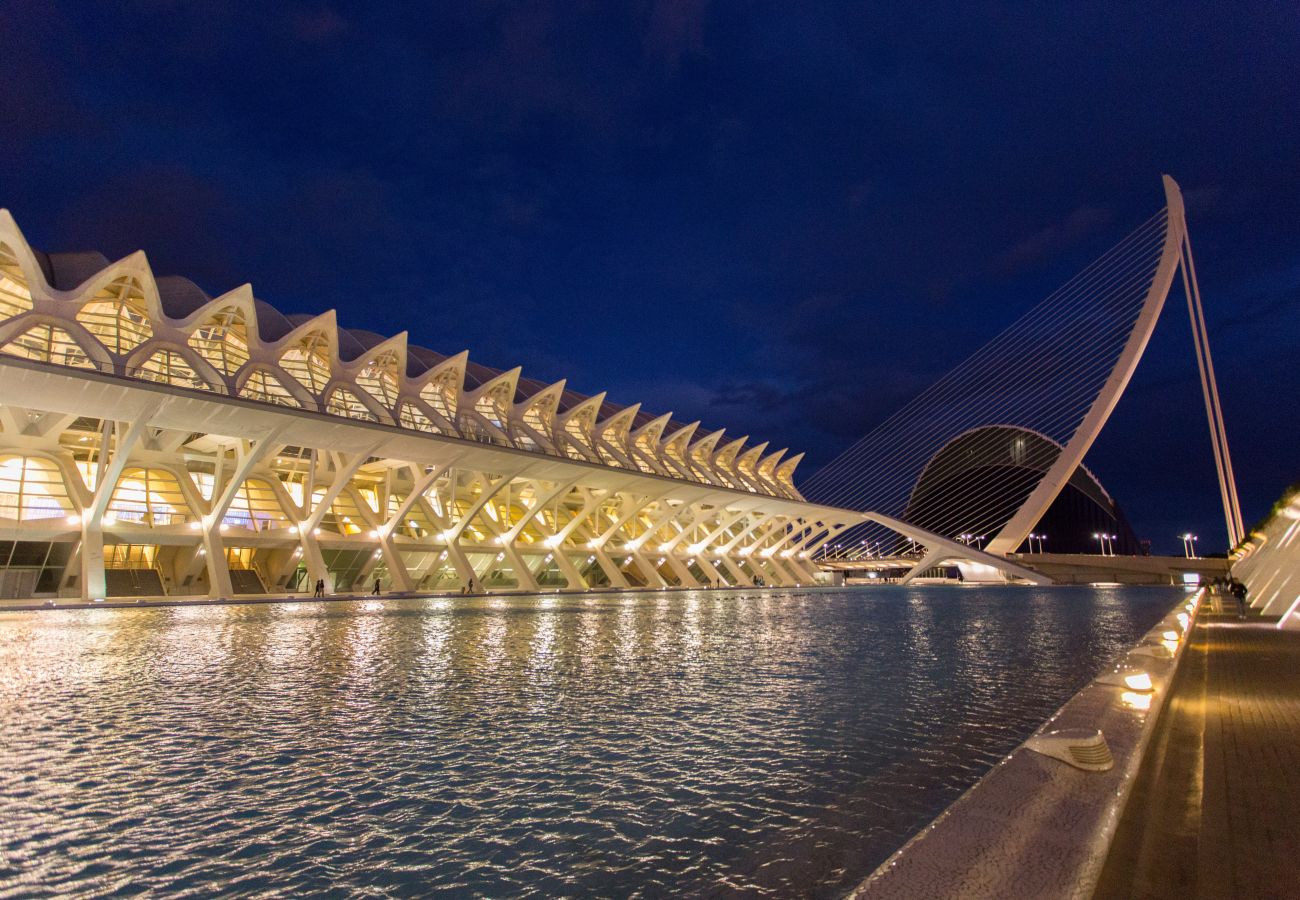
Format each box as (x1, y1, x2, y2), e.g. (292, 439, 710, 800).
(0, 212, 878, 600)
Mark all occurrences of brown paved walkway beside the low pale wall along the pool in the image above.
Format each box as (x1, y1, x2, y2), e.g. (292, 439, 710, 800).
(1097, 598, 1300, 900)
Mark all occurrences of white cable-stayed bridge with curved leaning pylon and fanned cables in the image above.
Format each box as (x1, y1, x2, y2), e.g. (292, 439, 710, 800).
(801, 176, 1244, 580)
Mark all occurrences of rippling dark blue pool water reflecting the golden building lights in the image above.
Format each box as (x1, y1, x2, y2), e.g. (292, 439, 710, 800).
(0, 587, 1180, 896)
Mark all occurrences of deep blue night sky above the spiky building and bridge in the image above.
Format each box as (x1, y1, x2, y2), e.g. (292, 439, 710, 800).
(0, 0, 1300, 551)
